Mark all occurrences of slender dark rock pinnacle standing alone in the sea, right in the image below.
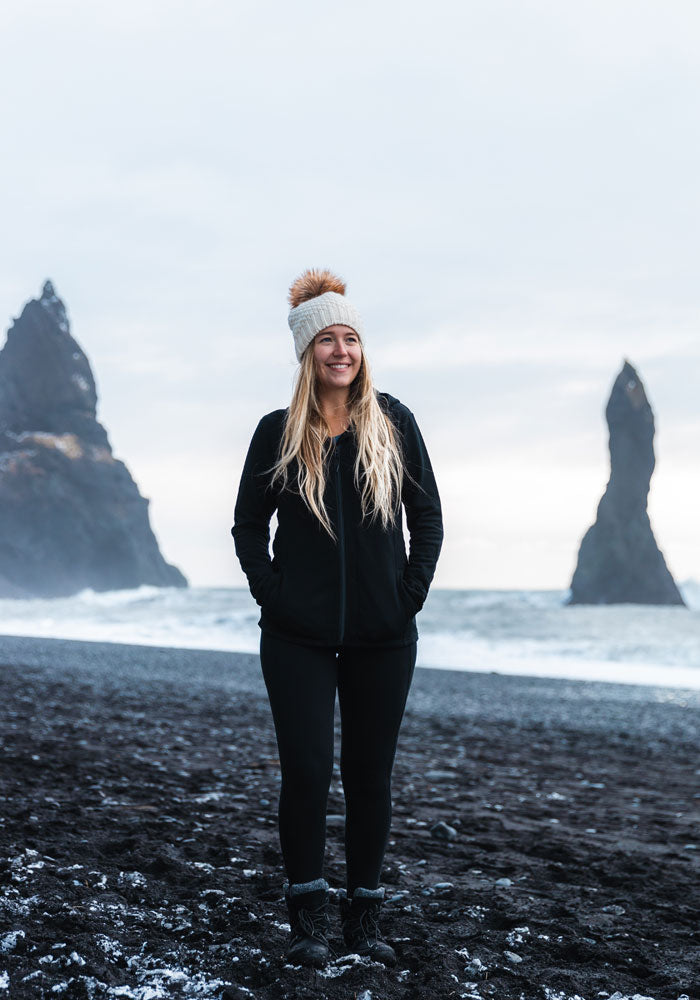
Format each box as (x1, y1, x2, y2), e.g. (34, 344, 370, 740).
(569, 361, 684, 604)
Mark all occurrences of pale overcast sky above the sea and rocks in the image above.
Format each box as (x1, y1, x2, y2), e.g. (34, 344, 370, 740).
(0, 0, 700, 587)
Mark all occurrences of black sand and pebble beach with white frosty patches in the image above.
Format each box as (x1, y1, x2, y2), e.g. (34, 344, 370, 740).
(0, 637, 700, 1000)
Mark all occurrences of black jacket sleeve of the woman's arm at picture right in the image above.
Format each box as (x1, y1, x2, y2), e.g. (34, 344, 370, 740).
(401, 407, 444, 611)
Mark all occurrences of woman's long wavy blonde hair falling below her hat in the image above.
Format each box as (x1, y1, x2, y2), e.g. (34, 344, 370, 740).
(269, 337, 405, 541)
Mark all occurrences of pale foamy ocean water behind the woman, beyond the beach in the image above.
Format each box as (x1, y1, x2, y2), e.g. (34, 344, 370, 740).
(0, 581, 700, 688)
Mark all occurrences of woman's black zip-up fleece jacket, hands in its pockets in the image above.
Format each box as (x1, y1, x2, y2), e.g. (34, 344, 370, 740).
(231, 392, 443, 647)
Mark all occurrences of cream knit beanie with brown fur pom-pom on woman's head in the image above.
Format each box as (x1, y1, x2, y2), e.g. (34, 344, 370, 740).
(288, 268, 364, 361)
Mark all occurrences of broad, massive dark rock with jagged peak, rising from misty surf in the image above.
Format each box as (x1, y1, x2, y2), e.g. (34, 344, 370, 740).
(0, 281, 187, 597)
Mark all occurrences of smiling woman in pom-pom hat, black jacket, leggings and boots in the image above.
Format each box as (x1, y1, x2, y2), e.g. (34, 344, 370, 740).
(231, 270, 443, 965)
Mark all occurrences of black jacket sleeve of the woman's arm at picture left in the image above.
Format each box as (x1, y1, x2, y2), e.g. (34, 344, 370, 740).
(231, 417, 277, 604)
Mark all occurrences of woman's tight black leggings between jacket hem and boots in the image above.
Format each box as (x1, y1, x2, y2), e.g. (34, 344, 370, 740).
(260, 632, 416, 894)
